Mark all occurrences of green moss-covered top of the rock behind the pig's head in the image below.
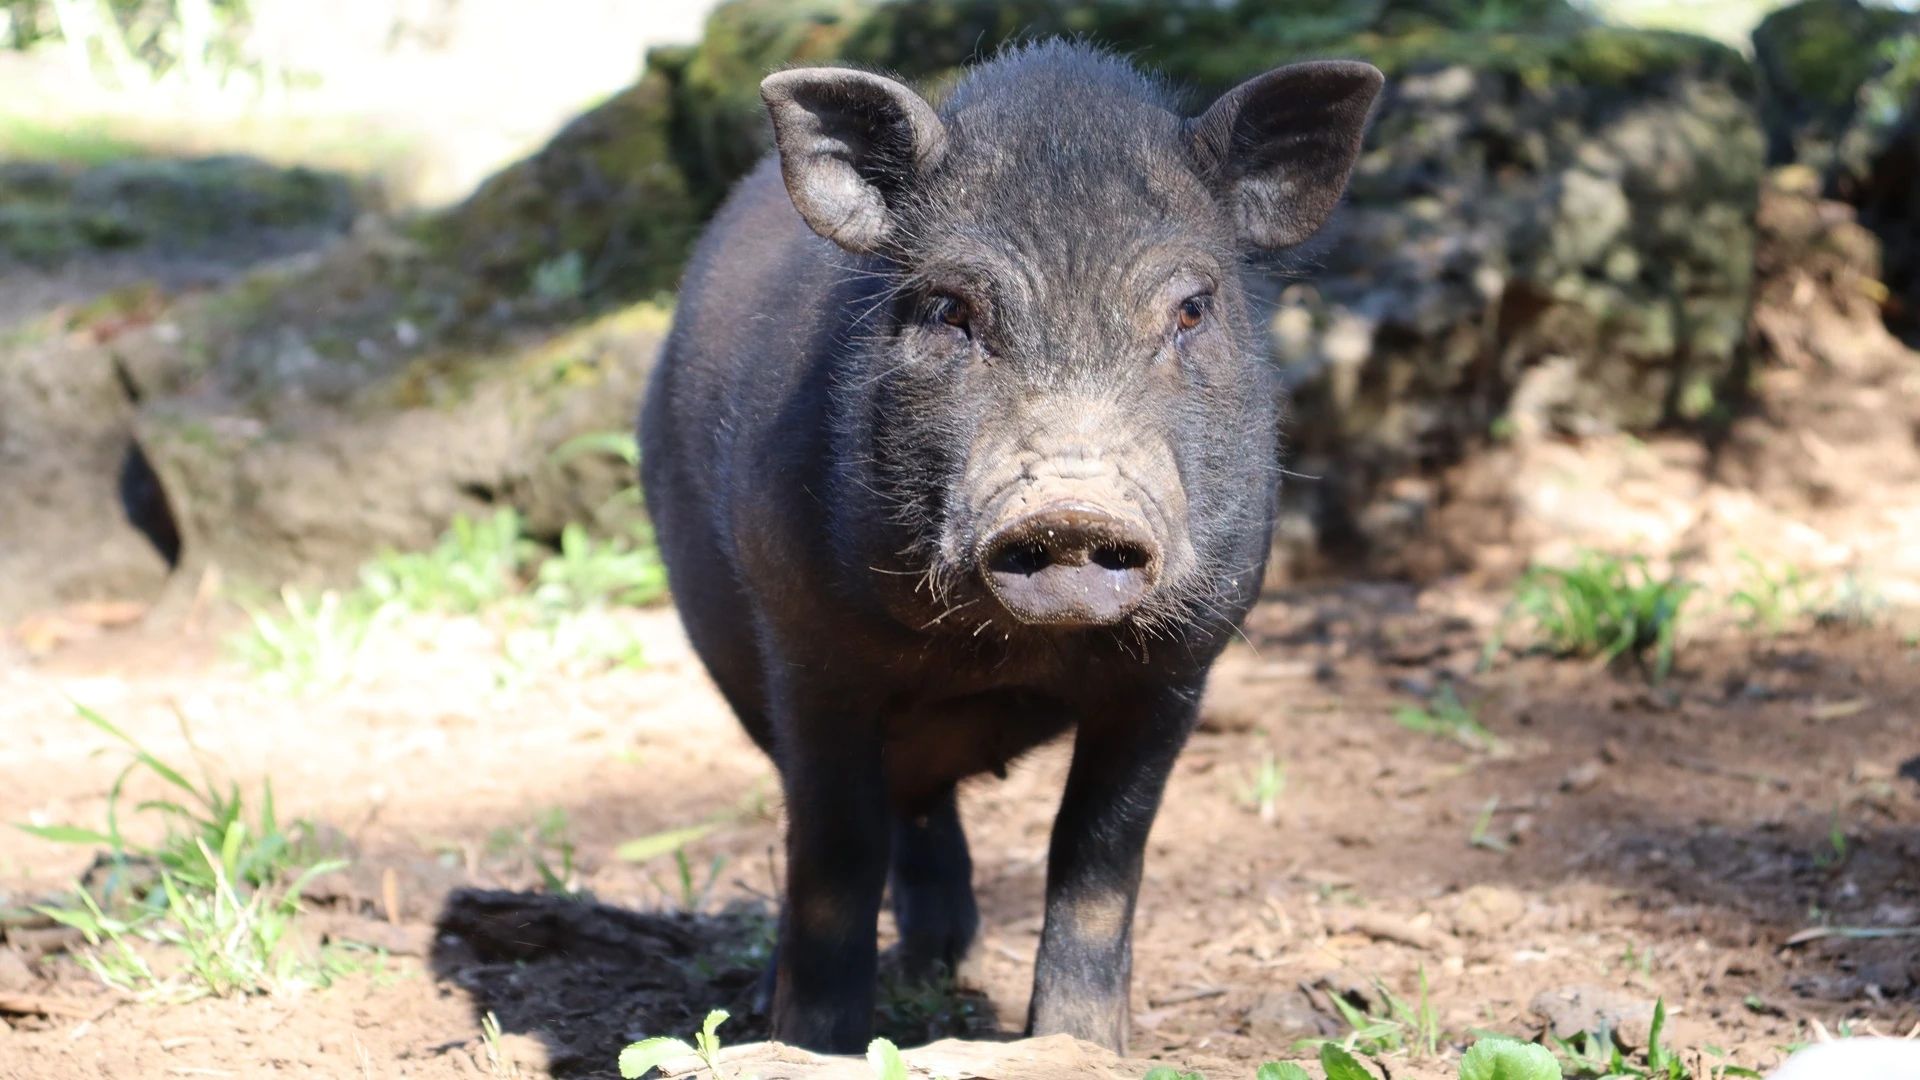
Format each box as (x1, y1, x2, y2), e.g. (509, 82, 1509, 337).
(419, 0, 1753, 307)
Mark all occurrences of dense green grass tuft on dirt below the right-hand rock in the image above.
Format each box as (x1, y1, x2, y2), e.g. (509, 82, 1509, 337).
(1482, 552, 1697, 682)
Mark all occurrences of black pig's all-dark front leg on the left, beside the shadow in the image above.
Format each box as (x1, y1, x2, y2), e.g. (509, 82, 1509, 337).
(774, 686, 889, 1053)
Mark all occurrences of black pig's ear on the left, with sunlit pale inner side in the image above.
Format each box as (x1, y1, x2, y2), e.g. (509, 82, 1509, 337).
(760, 67, 947, 254)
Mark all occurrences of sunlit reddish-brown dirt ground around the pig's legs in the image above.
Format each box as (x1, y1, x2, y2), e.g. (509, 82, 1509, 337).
(0, 553, 1920, 1080)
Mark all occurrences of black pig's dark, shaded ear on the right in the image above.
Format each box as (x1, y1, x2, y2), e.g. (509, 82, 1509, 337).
(1192, 60, 1384, 250)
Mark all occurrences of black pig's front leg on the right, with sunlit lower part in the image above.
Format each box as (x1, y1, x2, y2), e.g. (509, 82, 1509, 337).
(1027, 684, 1200, 1053)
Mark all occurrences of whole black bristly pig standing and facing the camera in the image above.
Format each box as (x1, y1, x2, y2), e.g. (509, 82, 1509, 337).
(641, 44, 1380, 1053)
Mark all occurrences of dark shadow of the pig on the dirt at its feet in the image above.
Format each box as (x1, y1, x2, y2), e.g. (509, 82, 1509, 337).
(432, 890, 996, 1078)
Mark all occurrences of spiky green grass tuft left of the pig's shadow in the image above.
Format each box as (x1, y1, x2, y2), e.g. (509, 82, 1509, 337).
(19, 705, 346, 1001)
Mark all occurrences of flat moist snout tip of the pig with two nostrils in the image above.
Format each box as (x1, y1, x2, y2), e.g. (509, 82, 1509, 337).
(981, 503, 1160, 626)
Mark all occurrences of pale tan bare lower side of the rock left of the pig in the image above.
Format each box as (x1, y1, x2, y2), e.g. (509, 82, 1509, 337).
(134, 295, 666, 600)
